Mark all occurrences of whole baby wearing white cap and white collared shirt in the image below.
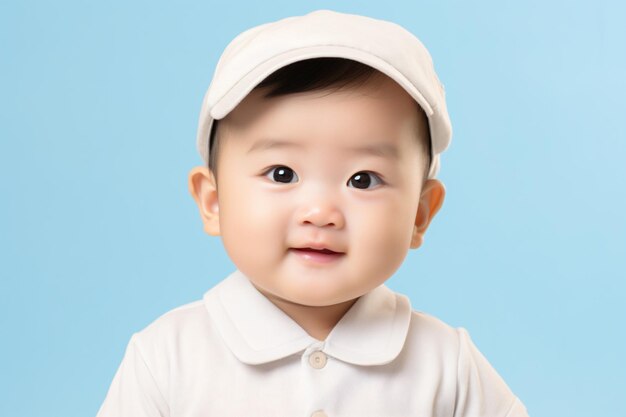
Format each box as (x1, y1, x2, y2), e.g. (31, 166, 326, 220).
(98, 10, 527, 417)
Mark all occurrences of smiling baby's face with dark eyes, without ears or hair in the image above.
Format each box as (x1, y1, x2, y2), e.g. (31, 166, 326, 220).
(217, 78, 425, 306)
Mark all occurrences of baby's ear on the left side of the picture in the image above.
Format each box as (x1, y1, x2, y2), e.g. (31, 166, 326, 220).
(189, 166, 220, 236)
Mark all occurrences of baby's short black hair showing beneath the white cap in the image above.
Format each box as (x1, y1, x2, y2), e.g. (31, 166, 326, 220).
(208, 57, 431, 180)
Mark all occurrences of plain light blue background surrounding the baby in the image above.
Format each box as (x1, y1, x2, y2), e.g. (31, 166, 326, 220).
(0, 0, 626, 417)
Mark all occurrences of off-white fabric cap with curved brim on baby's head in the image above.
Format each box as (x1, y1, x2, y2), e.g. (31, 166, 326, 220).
(197, 10, 452, 178)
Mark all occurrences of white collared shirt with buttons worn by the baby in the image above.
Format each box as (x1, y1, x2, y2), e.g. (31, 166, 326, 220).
(97, 271, 528, 417)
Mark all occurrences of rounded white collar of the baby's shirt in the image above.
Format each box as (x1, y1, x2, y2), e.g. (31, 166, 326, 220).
(204, 270, 411, 365)
